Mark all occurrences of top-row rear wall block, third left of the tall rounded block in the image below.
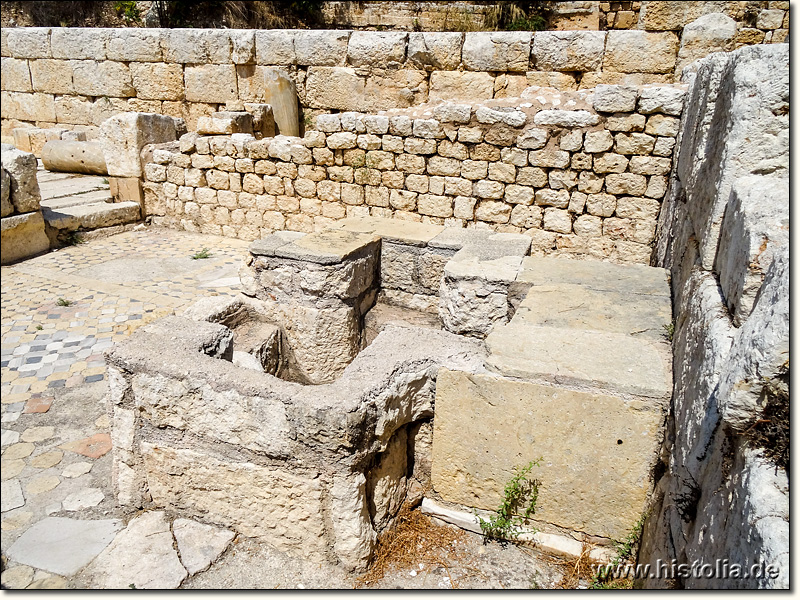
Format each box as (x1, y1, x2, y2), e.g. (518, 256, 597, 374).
(461, 31, 531, 71)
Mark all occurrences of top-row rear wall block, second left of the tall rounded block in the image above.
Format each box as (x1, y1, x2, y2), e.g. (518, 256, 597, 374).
(531, 31, 606, 71)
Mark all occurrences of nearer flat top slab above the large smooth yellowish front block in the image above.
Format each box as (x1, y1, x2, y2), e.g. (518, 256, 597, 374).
(486, 323, 672, 399)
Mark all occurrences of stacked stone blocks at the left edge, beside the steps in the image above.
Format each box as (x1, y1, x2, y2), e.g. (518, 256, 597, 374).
(0, 144, 50, 265)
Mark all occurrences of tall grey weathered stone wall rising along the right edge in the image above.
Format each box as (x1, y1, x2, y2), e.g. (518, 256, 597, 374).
(640, 45, 790, 588)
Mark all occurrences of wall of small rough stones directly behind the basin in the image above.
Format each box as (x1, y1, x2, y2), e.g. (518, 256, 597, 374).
(144, 86, 684, 263)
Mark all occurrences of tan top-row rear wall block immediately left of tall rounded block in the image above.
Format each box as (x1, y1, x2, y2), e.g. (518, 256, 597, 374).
(603, 31, 678, 73)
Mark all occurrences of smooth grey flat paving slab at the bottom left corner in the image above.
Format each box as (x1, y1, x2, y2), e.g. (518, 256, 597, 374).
(7, 517, 122, 577)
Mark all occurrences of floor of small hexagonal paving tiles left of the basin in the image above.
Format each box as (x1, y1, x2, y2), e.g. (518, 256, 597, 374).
(0, 228, 247, 589)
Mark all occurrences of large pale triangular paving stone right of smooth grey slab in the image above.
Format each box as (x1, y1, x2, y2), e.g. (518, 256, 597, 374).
(84, 511, 188, 589)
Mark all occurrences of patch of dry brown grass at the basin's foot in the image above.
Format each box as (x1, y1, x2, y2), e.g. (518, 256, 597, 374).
(356, 504, 473, 588)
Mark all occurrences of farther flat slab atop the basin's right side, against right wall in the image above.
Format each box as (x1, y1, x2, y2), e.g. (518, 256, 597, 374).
(511, 284, 672, 342)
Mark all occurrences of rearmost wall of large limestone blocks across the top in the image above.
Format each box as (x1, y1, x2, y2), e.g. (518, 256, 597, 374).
(0, 14, 788, 141)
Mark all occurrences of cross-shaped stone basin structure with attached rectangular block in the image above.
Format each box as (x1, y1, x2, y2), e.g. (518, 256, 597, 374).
(107, 218, 671, 571)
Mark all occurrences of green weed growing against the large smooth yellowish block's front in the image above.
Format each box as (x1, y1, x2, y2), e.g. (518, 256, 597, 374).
(478, 458, 542, 540)
